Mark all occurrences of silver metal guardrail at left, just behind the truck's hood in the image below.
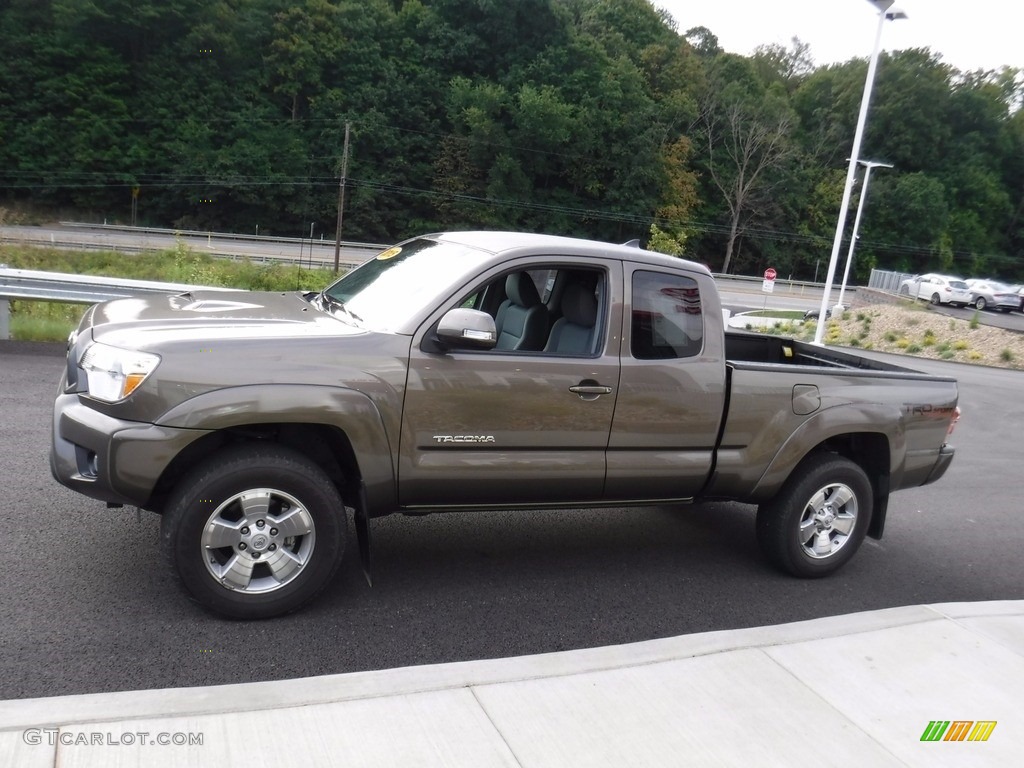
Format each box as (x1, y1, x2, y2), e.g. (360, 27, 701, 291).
(0, 266, 240, 339)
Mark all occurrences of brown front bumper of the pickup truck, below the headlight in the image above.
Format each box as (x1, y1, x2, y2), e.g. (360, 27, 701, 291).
(50, 394, 207, 507)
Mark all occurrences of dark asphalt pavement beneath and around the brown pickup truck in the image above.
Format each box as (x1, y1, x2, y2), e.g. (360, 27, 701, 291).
(0, 342, 1024, 699)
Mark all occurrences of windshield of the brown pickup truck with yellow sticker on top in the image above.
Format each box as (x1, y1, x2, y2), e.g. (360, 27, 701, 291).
(322, 239, 491, 331)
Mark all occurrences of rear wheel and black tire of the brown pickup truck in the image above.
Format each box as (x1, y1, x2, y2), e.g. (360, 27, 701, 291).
(757, 454, 874, 579)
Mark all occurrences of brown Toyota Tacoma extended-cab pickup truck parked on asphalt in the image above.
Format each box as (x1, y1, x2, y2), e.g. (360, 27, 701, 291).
(51, 232, 958, 617)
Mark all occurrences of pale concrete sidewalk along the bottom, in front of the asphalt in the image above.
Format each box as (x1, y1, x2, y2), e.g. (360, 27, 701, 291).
(0, 600, 1024, 768)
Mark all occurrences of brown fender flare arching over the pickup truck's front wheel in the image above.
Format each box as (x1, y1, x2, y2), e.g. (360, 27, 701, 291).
(157, 384, 397, 516)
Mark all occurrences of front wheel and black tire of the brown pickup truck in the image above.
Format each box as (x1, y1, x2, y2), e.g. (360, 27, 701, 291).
(161, 444, 348, 618)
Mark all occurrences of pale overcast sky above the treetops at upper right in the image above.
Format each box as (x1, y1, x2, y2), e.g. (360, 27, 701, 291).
(652, 0, 1024, 71)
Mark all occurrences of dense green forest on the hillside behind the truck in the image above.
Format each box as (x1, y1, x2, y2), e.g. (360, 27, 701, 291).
(0, 0, 1024, 280)
